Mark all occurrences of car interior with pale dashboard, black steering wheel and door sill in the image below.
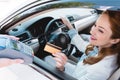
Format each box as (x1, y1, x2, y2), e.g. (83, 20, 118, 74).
(0, 0, 120, 80)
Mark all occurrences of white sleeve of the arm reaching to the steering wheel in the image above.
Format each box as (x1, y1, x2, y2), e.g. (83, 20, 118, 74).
(71, 34, 89, 52)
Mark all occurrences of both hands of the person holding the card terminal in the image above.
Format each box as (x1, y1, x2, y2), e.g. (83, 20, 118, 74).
(0, 35, 24, 68)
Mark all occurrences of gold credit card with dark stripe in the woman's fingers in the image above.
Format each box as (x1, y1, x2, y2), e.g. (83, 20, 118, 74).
(44, 42, 62, 54)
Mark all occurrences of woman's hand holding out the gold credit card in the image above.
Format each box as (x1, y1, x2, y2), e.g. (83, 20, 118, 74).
(53, 53, 68, 71)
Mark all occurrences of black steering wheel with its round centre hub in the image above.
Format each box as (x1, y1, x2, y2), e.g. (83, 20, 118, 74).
(37, 19, 77, 56)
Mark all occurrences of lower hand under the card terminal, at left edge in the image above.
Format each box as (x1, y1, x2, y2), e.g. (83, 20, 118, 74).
(0, 58, 24, 68)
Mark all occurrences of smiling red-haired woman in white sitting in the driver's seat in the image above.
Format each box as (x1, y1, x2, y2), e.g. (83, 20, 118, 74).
(53, 10, 120, 80)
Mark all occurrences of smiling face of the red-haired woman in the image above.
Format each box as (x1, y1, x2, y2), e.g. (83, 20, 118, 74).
(90, 14, 113, 48)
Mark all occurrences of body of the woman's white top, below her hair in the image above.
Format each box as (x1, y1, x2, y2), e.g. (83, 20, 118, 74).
(73, 55, 117, 80)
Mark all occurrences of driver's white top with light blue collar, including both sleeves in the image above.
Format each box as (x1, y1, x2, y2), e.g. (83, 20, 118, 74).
(65, 34, 118, 80)
